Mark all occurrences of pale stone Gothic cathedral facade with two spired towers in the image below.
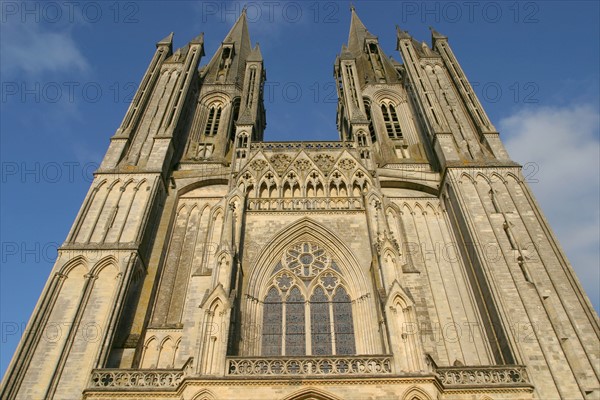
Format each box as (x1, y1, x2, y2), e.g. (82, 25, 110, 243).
(0, 10, 600, 400)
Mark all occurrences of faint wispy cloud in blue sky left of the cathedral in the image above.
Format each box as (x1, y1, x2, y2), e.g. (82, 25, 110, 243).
(0, 21, 89, 75)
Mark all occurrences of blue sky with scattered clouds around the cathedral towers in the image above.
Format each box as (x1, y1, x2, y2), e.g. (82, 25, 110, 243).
(0, 1, 600, 374)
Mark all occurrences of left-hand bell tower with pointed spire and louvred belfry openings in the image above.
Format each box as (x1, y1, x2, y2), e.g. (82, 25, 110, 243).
(182, 9, 265, 163)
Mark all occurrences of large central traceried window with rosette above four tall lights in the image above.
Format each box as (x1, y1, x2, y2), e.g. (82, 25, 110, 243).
(262, 242, 356, 356)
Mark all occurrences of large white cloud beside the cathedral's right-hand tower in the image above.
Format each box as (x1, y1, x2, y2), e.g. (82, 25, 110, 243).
(499, 104, 600, 309)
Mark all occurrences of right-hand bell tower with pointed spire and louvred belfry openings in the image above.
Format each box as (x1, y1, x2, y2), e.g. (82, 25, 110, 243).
(334, 7, 429, 165)
